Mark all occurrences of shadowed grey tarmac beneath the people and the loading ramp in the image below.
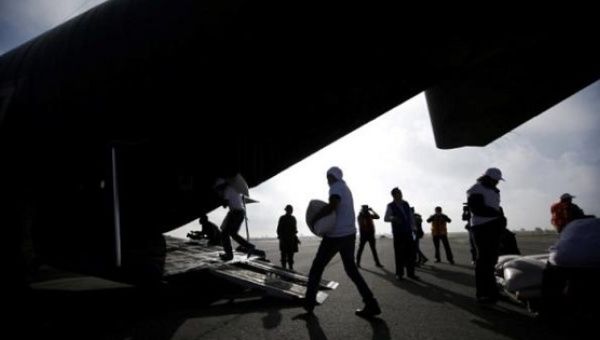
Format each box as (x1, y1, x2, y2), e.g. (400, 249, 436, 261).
(23, 233, 593, 340)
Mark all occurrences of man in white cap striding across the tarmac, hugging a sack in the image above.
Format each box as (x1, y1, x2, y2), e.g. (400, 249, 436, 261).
(304, 166, 381, 317)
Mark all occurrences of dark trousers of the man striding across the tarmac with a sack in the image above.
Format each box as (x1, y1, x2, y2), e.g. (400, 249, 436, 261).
(306, 235, 373, 304)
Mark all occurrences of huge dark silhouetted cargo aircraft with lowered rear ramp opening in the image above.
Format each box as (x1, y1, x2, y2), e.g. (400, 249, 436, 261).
(0, 0, 600, 292)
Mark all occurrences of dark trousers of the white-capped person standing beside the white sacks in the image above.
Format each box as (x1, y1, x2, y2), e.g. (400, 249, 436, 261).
(471, 220, 503, 298)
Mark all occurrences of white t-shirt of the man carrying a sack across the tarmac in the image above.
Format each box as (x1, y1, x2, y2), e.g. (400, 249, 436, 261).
(325, 181, 356, 237)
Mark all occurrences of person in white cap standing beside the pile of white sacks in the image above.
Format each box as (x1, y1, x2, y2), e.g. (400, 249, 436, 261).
(467, 168, 506, 303)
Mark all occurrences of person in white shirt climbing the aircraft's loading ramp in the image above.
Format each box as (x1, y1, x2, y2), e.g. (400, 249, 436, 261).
(215, 178, 256, 261)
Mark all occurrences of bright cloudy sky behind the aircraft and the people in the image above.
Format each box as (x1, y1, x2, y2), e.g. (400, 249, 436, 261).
(0, 0, 600, 237)
